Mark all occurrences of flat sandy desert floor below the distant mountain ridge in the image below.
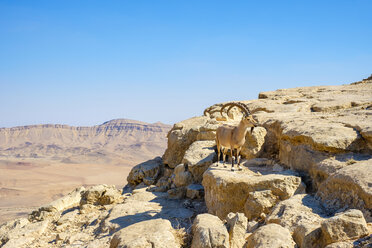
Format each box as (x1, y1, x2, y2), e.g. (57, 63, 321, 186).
(0, 159, 135, 224)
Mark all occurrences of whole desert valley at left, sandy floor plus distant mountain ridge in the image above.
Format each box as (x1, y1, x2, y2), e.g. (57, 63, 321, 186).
(0, 119, 171, 223)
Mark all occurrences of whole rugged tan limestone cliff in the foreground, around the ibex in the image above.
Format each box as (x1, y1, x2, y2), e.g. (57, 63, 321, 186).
(0, 78, 372, 248)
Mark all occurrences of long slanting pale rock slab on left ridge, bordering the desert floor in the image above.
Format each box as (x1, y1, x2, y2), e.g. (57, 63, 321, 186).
(29, 187, 85, 221)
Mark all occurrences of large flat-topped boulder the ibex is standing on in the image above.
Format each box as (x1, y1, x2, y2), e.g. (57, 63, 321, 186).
(203, 166, 301, 219)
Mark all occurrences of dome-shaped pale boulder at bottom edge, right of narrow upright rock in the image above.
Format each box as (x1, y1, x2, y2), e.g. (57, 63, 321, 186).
(246, 224, 296, 248)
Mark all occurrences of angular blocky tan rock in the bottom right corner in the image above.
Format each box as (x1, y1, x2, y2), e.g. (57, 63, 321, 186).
(321, 209, 369, 244)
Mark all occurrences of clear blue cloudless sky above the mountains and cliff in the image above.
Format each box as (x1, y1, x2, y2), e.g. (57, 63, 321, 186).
(0, 0, 372, 127)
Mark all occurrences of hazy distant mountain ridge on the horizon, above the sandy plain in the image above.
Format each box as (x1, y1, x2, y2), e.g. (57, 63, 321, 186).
(0, 119, 171, 164)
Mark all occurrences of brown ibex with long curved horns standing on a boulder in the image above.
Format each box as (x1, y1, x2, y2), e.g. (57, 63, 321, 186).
(216, 102, 257, 171)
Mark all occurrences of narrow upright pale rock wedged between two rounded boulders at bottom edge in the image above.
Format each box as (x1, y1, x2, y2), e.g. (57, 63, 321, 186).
(226, 213, 248, 248)
